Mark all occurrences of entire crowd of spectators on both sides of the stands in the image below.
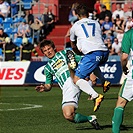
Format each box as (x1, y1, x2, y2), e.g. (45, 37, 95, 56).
(0, 0, 133, 61)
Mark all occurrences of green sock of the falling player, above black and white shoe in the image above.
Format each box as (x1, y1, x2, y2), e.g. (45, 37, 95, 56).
(74, 113, 92, 123)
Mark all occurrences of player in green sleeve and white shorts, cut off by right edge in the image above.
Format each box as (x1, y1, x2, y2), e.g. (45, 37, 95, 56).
(112, 29, 133, 133)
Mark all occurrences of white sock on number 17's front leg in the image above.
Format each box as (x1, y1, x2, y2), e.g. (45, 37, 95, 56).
(76, 79, 98, 99)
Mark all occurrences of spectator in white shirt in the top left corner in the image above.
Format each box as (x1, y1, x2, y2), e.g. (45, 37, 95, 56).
(0, 0, 10, 19)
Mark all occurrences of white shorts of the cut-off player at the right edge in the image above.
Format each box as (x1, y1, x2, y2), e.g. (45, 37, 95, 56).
(119, 70, 133, 101)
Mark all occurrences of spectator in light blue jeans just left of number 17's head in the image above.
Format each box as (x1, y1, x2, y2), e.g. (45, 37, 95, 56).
(68, 2, 79, 25)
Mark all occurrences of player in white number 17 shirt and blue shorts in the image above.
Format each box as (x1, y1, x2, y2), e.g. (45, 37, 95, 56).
(70, 4, 110, 102)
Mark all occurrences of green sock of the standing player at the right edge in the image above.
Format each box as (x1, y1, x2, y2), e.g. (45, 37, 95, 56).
(112, 107, 124, 133)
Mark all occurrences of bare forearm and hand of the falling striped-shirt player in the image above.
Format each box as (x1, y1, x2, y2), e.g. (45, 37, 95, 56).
(35, 84, 52, 92)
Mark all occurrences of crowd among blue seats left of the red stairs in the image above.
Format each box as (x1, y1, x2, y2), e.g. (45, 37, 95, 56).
(0, 0, 55, 61)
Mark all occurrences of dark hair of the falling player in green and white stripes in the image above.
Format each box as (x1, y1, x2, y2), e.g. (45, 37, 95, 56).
(39, 39, 55, 53)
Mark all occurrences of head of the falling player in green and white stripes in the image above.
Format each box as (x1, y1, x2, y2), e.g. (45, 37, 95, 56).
(39, 39, 56, 58)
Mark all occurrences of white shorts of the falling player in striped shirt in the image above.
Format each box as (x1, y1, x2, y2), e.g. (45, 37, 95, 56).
(62, 78, 81, 108)
